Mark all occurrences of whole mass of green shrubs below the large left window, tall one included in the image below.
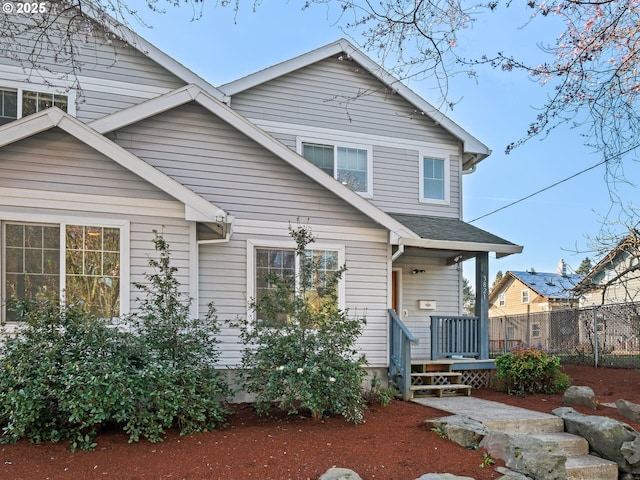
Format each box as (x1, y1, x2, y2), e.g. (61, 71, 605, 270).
(0, 233, 229, 450)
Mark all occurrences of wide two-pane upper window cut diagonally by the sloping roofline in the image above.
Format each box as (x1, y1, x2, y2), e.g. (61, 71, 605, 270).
(300, 142, 372, 196)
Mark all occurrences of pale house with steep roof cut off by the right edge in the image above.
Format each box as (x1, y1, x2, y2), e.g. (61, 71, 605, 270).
(575, 231, 640, 307)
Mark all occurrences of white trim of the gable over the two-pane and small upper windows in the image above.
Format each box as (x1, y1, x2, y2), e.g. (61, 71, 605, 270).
(218, 38, 491, 170)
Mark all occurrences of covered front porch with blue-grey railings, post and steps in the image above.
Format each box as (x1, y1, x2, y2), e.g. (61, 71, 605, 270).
(389, 215, 522, 399)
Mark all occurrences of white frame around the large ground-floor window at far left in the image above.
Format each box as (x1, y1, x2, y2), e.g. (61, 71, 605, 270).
(0, 212, 131, 324)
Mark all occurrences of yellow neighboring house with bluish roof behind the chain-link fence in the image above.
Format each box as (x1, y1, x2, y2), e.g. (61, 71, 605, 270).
(489, 260, 583, 351)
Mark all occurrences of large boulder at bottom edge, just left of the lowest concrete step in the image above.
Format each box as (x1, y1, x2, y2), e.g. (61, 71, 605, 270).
(480, 432, 567, 480)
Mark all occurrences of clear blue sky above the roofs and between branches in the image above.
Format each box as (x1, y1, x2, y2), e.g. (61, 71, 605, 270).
(125, 0, 640, 281)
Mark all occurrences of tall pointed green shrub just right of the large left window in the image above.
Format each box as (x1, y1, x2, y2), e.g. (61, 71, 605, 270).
(125, 235, 230, 441)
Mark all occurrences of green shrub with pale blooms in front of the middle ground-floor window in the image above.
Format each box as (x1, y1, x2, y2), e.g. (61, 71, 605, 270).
(232, 227, 366, 423)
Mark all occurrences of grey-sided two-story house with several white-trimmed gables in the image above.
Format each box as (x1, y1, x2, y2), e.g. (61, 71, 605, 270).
(0, 10, 522, 398)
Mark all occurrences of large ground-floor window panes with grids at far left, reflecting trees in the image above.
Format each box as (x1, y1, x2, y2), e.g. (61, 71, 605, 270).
(1, 221, 122, 321)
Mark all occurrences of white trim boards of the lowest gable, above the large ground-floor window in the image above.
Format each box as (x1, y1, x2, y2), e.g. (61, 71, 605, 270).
(0, 107, 232, 222)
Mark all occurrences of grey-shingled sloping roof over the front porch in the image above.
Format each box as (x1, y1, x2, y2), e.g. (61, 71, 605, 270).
(390, 213, 522, 258)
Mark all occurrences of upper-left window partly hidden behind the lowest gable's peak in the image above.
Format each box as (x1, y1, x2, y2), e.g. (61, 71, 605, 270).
(0, 88, 69, 125)
